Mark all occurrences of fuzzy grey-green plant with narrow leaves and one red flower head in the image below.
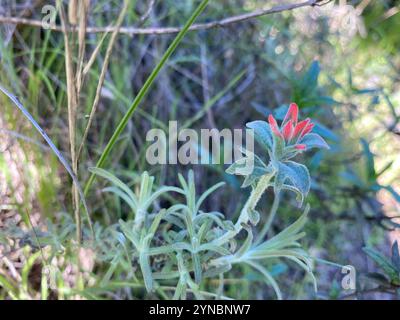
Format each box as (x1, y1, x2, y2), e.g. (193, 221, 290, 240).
(87, 103, 328, 299)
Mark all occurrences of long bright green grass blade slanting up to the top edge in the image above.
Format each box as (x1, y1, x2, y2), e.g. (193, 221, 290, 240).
(84, 0, 209, 195)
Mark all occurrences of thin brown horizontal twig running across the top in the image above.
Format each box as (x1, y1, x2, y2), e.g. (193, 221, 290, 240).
(0, 0, 324, 35)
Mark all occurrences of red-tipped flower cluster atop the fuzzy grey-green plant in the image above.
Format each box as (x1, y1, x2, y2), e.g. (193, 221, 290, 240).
(268, 103, 314, 150)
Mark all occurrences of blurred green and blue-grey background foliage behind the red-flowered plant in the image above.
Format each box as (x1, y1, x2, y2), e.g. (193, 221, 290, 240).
(0, 0, 400, 299)
